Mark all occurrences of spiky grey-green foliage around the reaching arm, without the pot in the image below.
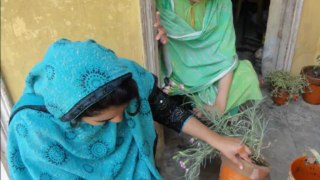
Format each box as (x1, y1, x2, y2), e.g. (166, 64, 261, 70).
(173, 95, 268, 179)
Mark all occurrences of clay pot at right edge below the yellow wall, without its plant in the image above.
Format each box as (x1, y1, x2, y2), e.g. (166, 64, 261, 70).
(301, 66, 320, 105)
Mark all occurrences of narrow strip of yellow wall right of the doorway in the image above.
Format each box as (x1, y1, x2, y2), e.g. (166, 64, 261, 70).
(291, 0, 320, 74)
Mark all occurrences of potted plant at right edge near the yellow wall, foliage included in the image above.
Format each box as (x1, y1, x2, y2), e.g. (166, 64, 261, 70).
(301, 55, 320, 105)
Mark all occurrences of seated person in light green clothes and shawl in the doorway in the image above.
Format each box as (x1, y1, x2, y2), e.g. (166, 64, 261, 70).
(155, 0, 262, 112)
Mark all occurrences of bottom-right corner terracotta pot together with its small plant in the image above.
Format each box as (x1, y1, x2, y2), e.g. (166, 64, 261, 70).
(289, 149, 320, 180)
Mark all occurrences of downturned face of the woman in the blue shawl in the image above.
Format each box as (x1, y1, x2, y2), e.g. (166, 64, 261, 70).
(82, 104, 128, 125)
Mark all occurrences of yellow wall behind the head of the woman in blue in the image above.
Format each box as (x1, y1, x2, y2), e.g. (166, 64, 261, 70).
(1, 0, 144, 101)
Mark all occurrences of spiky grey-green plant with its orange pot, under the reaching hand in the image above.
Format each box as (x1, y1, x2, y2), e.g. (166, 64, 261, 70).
(173, 97, 269, 180)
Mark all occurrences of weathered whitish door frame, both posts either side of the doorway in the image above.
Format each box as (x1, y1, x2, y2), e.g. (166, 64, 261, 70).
(140, 0, 304, 75)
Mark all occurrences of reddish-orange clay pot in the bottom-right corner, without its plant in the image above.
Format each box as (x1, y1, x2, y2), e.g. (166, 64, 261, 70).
(289, 156, 320, 180)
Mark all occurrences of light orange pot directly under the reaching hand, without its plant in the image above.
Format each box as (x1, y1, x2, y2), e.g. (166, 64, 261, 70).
(219, 156, 270, 180)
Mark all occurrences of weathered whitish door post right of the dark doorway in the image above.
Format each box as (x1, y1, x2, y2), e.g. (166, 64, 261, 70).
(262, 0, 304, 76)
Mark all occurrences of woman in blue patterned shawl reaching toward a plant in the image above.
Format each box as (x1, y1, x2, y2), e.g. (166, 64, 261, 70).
(7, 39, 250, 180)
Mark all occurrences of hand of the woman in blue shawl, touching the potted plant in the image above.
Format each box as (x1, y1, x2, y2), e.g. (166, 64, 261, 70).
(216, 136, 252, 169)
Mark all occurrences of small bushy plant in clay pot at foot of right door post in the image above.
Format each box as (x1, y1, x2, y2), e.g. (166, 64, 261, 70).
(266, 70, 308, 105)
